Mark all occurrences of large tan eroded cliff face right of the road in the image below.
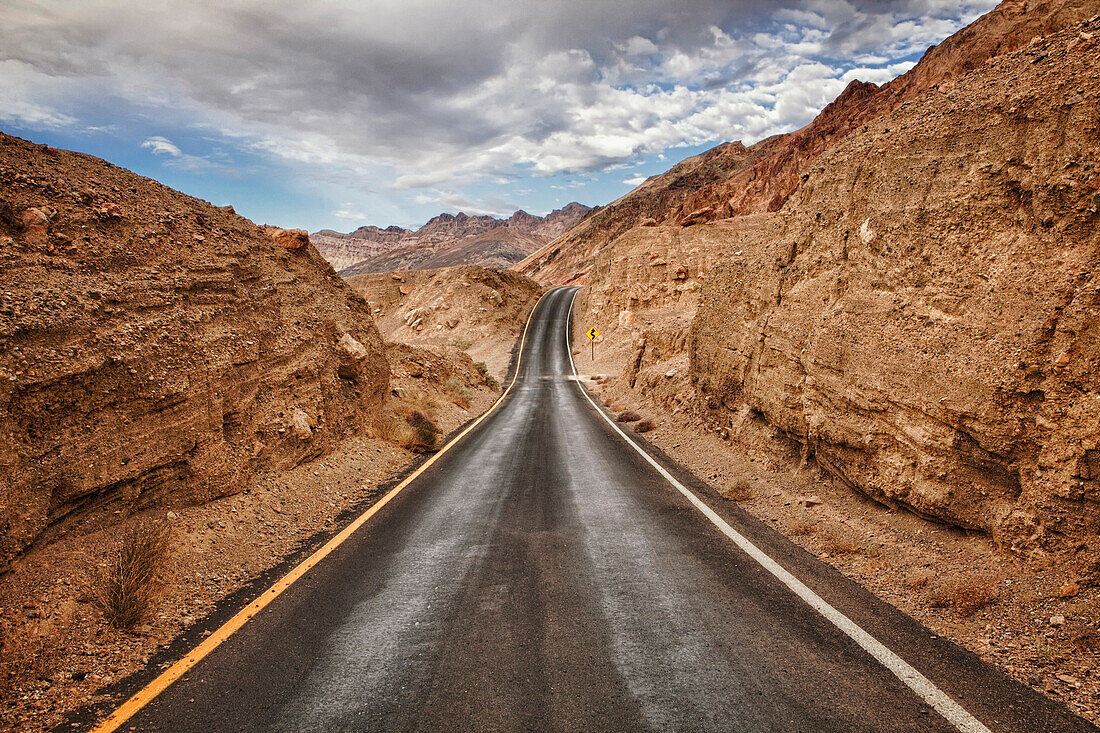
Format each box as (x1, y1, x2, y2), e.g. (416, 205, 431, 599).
(563, 2, 1100, 554)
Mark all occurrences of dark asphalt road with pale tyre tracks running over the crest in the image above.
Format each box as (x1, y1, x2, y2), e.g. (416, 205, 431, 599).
(109, 288, 1095, 732)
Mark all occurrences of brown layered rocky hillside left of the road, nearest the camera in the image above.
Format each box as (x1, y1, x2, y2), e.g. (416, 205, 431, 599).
(0, 129, 389, 567)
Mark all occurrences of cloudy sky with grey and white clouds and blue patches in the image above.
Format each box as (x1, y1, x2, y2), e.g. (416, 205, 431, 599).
(0, 0, 996, 231)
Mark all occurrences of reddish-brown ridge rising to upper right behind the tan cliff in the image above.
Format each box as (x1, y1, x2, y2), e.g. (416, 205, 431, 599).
(518, 0, 1100, 284)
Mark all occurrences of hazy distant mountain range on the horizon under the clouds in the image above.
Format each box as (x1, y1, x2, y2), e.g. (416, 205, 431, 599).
(309, 201, 594, 276)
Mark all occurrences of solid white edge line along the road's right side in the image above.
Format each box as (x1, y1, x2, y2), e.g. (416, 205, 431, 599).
(565, 288, 990, 733)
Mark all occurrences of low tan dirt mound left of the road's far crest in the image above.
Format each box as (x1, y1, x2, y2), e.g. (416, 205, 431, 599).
(348, 265, 541, 381)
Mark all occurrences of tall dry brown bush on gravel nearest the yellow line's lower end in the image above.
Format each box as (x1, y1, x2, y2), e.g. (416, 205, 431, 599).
(91, 522, 171, 631)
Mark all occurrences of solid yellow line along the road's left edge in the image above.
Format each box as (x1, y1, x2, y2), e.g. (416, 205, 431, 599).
(92, 294, 547, 733)
